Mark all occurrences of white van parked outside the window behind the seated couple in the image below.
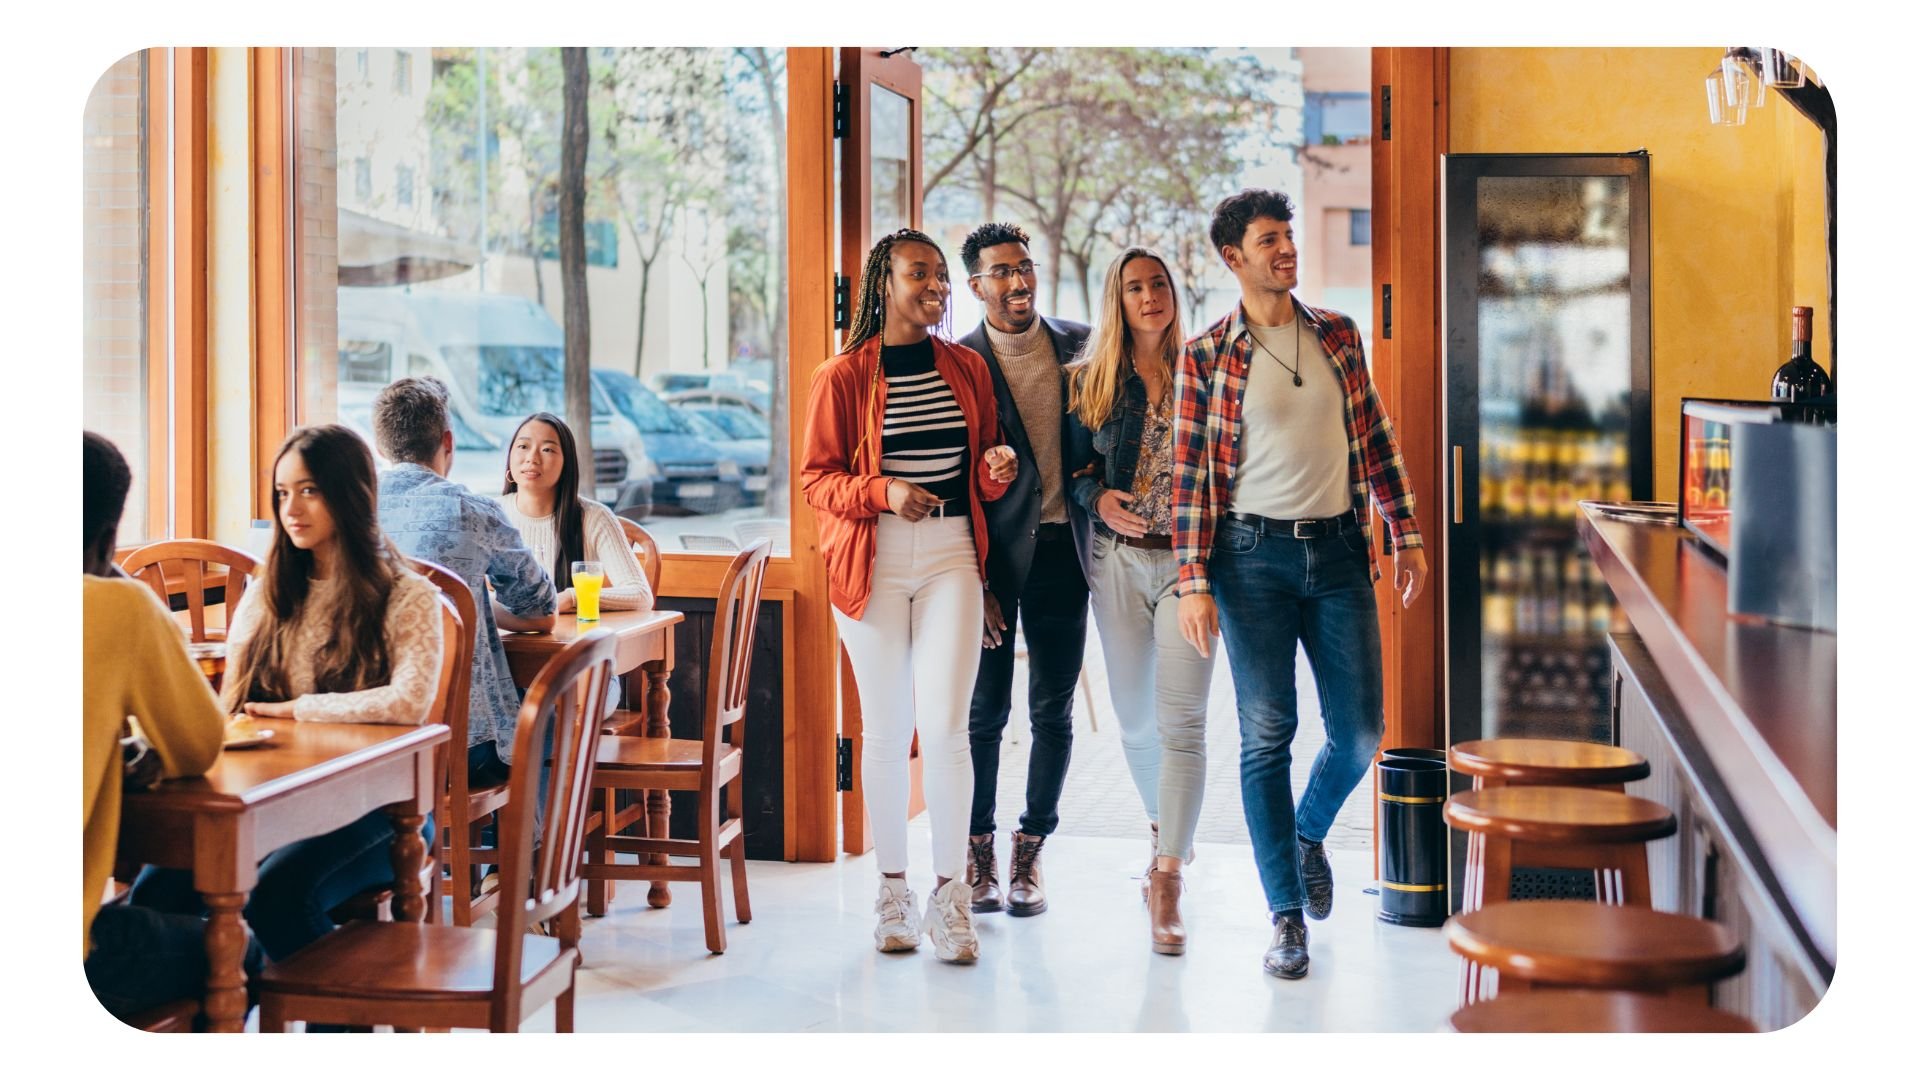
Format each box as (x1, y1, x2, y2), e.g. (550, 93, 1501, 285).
(340, 286, 653, 517)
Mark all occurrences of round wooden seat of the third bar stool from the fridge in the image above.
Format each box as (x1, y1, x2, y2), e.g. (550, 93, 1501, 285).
(1446, 899, 1747, 990)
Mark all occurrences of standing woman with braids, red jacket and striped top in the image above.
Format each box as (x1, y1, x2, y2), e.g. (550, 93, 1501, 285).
(801, 229, 1018, 963)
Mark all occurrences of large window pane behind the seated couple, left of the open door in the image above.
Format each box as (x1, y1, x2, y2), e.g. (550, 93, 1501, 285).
(296, 48, 787, 552)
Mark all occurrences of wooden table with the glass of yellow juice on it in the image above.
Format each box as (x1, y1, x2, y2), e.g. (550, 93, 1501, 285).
(499, 609, 685, 915)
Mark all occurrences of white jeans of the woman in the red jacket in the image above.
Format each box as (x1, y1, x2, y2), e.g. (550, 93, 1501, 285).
(833, 513, 985, 878)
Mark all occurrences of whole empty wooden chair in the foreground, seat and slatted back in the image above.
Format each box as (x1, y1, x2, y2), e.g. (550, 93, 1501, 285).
(259, 630, 614, 1032)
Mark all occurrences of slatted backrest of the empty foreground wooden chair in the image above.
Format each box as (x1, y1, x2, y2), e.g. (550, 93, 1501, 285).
(487, 630, 616, 1020)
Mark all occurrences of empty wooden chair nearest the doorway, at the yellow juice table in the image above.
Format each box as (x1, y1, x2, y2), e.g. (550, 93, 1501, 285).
(580, 540, 772, 953)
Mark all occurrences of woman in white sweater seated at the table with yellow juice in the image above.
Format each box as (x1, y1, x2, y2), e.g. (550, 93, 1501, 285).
(503, 413, 653, 611)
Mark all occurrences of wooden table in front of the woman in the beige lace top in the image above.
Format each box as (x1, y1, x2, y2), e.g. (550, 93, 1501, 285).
(119, 721, 447, 1032)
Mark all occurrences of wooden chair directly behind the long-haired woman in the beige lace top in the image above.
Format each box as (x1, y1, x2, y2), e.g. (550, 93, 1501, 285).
(413, 559, 507, 926)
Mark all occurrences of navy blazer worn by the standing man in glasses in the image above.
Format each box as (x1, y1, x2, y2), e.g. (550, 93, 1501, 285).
(960, 315, 1092, 611)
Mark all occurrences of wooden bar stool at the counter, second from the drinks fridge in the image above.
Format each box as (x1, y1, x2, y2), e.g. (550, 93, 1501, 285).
(1446, 786, 1678, 1005)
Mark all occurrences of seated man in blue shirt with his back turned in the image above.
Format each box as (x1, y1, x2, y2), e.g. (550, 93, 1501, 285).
(372, 377, 555, 788)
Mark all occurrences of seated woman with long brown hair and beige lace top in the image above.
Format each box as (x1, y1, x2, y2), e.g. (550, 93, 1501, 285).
(134, 425, 442, 961)
